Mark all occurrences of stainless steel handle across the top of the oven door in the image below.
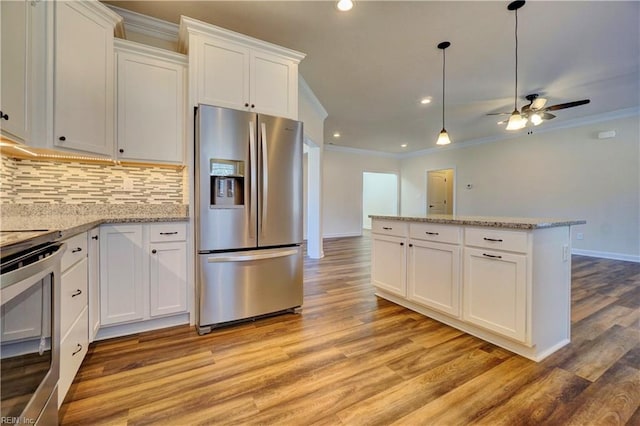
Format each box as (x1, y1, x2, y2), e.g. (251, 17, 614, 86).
(0, 243, 67, 305)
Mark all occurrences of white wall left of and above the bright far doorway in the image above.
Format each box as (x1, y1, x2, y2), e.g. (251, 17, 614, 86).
(323, 146, 400, 237)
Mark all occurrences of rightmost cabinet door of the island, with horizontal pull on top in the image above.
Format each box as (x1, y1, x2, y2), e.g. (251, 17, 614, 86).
(463, 248, 527, 342)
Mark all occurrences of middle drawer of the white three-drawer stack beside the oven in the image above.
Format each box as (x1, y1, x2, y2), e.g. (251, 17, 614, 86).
(60, 259, 88, 336)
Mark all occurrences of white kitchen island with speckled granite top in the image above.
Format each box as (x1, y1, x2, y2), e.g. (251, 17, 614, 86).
(370, 215, 586, 361)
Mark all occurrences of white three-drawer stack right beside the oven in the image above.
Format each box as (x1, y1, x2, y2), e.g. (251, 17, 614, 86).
(58, 232, 89, 407)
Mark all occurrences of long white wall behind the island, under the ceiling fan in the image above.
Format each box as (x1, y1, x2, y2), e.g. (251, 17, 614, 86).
(401, 115, 640, 260)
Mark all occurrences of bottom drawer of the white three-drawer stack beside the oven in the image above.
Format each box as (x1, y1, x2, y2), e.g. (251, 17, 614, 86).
(58, 309, 89, 408)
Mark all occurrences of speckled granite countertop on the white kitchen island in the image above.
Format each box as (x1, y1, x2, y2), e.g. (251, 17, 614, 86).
(369, 214, 587, 229)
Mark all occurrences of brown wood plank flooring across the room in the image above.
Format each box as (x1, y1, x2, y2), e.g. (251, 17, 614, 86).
(60, 236, 640, 426)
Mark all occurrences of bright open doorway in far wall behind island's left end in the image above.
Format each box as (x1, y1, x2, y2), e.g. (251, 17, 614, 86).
(362, 172, 398, 229)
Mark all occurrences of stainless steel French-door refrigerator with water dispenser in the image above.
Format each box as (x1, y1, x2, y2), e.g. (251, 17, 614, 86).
(195, 104, 303, 334)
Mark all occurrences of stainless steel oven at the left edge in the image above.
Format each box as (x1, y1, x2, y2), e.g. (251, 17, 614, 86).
(0, 243, 65, 426)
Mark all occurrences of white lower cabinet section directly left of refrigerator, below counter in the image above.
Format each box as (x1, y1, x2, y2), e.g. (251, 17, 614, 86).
(100, 223, 187, 326)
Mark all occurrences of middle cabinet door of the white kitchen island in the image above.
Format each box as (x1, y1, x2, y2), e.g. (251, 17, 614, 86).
(407, 240, 460, 317)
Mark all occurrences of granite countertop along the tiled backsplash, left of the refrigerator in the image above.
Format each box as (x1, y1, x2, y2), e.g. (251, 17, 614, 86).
(0, 204, 189, 248)
